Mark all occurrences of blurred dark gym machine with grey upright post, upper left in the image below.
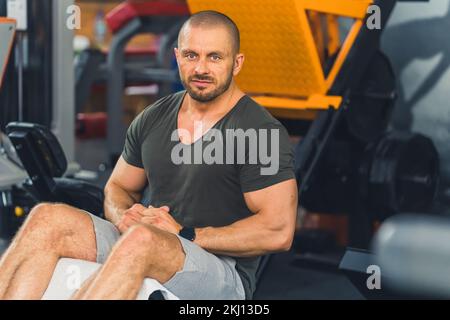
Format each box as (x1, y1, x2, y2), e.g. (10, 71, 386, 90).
(0, 0, 78, 161)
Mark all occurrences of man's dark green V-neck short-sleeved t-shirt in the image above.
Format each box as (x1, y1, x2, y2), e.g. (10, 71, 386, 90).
(122, 91, 295, 299)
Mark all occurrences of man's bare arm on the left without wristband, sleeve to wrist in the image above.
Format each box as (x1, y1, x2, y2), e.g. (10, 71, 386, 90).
(104, 157, 147, 225)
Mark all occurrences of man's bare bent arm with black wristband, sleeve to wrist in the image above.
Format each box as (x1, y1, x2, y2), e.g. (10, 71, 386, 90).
(195, 179, 298, 257)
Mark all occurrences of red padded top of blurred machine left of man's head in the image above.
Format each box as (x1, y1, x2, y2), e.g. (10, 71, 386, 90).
(106, 0, 190, 33)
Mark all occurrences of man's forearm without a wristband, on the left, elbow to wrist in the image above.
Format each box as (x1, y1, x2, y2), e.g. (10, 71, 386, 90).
(104, 182, 141, 225)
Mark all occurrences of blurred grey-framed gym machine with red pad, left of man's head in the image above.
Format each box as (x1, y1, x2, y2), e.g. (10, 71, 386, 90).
(76, 0, 189, 165)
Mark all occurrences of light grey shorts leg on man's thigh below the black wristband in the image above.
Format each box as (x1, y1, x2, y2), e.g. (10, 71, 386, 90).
(163, 237, 245, 300)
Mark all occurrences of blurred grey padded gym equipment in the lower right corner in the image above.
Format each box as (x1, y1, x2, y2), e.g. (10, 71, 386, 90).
(339, 213, 450, 299)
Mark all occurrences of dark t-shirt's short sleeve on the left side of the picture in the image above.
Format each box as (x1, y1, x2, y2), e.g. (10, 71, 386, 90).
(122, 114, 144, 168)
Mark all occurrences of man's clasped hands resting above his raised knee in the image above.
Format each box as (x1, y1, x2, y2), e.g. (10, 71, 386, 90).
(116, 204, 182, 234)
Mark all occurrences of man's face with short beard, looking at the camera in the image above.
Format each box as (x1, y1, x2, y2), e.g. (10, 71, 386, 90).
(175, 26, 239, 102)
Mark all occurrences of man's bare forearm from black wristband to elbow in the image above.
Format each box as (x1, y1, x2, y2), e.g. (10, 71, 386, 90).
(194, 215, 295, 257)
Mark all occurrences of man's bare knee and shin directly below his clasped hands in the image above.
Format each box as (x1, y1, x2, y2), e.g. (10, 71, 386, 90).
(79, 225, 185, 300)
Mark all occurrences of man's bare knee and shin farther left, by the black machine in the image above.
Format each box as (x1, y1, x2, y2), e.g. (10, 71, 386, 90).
(0, 204, 97, 299)
